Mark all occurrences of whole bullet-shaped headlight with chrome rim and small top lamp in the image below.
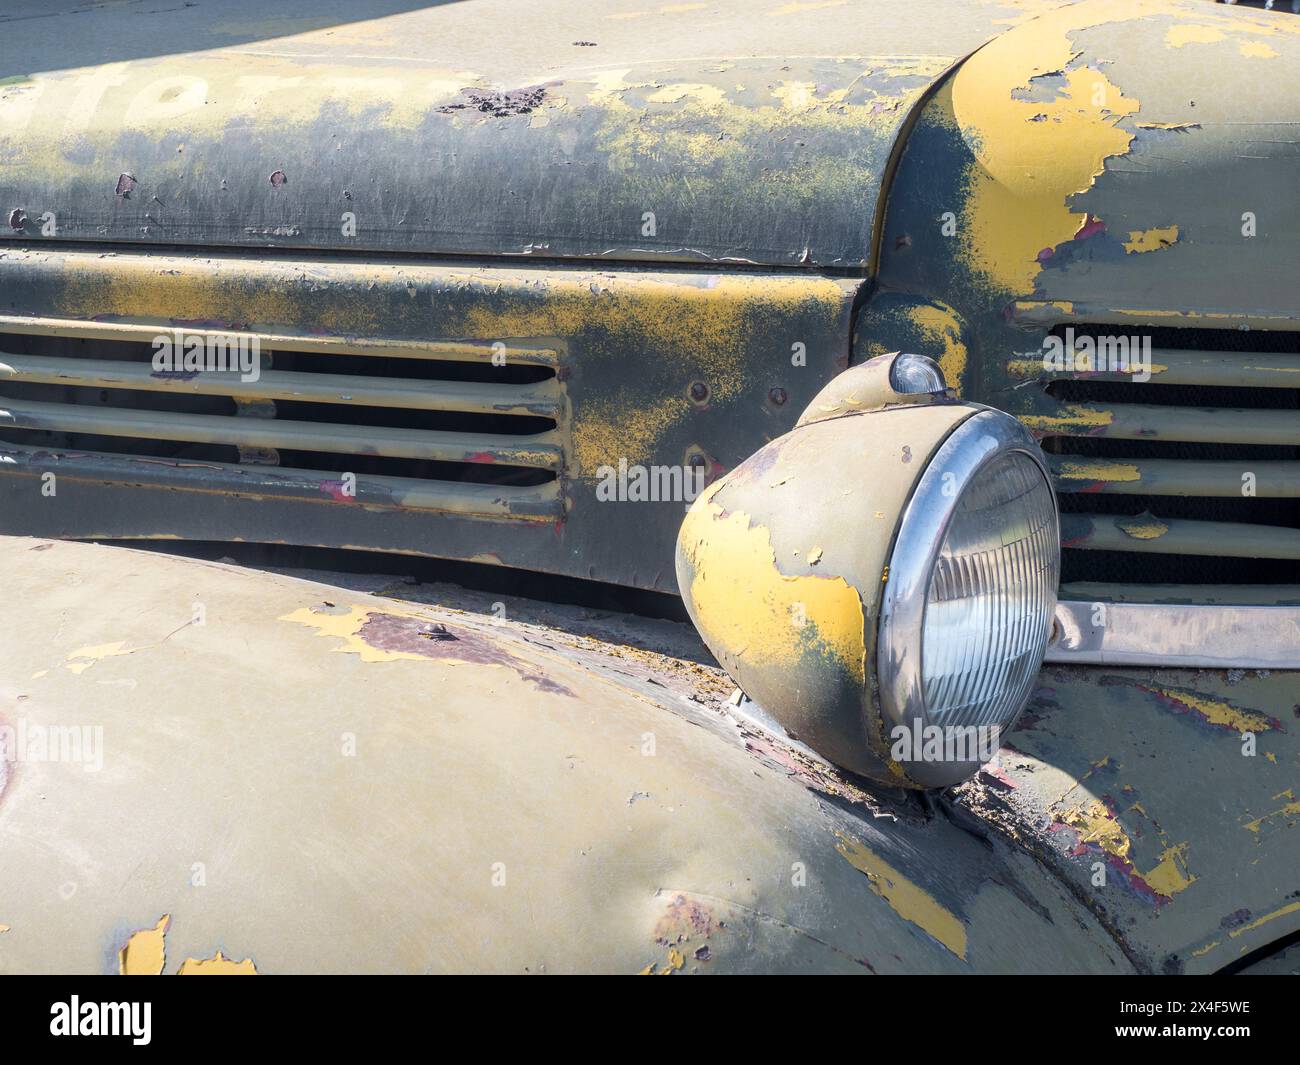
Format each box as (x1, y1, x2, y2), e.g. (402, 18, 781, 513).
(677, 355, 1060, 788)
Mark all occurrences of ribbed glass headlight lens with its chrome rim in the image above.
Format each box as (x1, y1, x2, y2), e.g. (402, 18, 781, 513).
(876, 411, 1061, 787)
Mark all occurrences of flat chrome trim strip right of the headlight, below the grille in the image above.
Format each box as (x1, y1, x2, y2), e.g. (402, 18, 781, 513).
(1047, 599, 1300, 670)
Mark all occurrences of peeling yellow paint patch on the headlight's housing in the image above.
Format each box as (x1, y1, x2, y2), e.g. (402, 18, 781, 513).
(679, 481, 867, 684)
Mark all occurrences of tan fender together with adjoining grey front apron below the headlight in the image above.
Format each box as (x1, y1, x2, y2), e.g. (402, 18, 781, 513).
(0, 537, 1300, 973)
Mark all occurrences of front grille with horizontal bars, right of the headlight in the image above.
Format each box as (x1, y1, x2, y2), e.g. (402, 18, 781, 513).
(1008, 325, 1300, 585)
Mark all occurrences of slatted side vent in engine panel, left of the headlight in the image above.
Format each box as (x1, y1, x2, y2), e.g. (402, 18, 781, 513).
(0, 316, 567, 520)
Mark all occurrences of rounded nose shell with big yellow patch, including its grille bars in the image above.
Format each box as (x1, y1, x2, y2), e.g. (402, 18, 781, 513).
(854, 0, 1300, 601)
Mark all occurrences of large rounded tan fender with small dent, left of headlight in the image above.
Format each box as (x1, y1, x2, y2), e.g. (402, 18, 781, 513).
(0, 537, 1128, 974)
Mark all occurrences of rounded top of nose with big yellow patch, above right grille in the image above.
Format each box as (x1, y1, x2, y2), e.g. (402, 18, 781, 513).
(881, 0, 1300, 326)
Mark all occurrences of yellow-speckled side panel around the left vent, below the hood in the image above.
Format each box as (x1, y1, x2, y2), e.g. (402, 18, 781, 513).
(0, 248, 861, 592)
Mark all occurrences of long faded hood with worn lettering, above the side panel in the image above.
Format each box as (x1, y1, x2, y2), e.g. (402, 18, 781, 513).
(0, 0, 1057, 269)
